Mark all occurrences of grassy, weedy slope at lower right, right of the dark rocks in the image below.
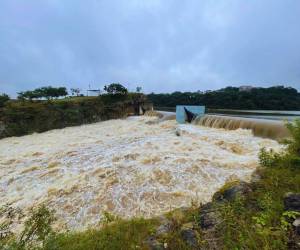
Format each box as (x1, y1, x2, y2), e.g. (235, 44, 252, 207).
(217, 166, 300, 249)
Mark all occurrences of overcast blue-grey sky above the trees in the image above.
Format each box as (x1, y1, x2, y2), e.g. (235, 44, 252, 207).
(0, 0, 300, 95)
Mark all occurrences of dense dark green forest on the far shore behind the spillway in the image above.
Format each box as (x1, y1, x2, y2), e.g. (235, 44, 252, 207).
(148, 86, 300, 110)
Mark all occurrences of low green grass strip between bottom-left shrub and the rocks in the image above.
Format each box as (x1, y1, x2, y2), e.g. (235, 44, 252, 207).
(44, 218, 158, 250)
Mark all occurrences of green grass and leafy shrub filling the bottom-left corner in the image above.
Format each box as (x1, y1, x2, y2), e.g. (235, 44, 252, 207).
(0, 213, 158, 250)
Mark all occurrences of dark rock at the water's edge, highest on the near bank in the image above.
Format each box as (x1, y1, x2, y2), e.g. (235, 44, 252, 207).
(213, 182, 251, 202)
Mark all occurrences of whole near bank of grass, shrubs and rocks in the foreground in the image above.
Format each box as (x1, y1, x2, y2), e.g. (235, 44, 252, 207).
(0, 121, 300, 250)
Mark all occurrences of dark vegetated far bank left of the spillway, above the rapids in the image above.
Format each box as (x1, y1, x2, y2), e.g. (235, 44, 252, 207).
(0, 93, 150, 138)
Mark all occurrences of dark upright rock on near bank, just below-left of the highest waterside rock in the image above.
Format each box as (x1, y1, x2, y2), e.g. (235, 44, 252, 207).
(199, 202, 221, 230)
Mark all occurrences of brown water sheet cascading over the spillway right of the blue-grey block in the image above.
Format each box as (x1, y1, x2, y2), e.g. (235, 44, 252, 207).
(193, 115, 289, 140)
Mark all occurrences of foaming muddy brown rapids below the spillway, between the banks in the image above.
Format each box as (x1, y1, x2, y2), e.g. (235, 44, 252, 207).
(0, 117, 281, 230)
